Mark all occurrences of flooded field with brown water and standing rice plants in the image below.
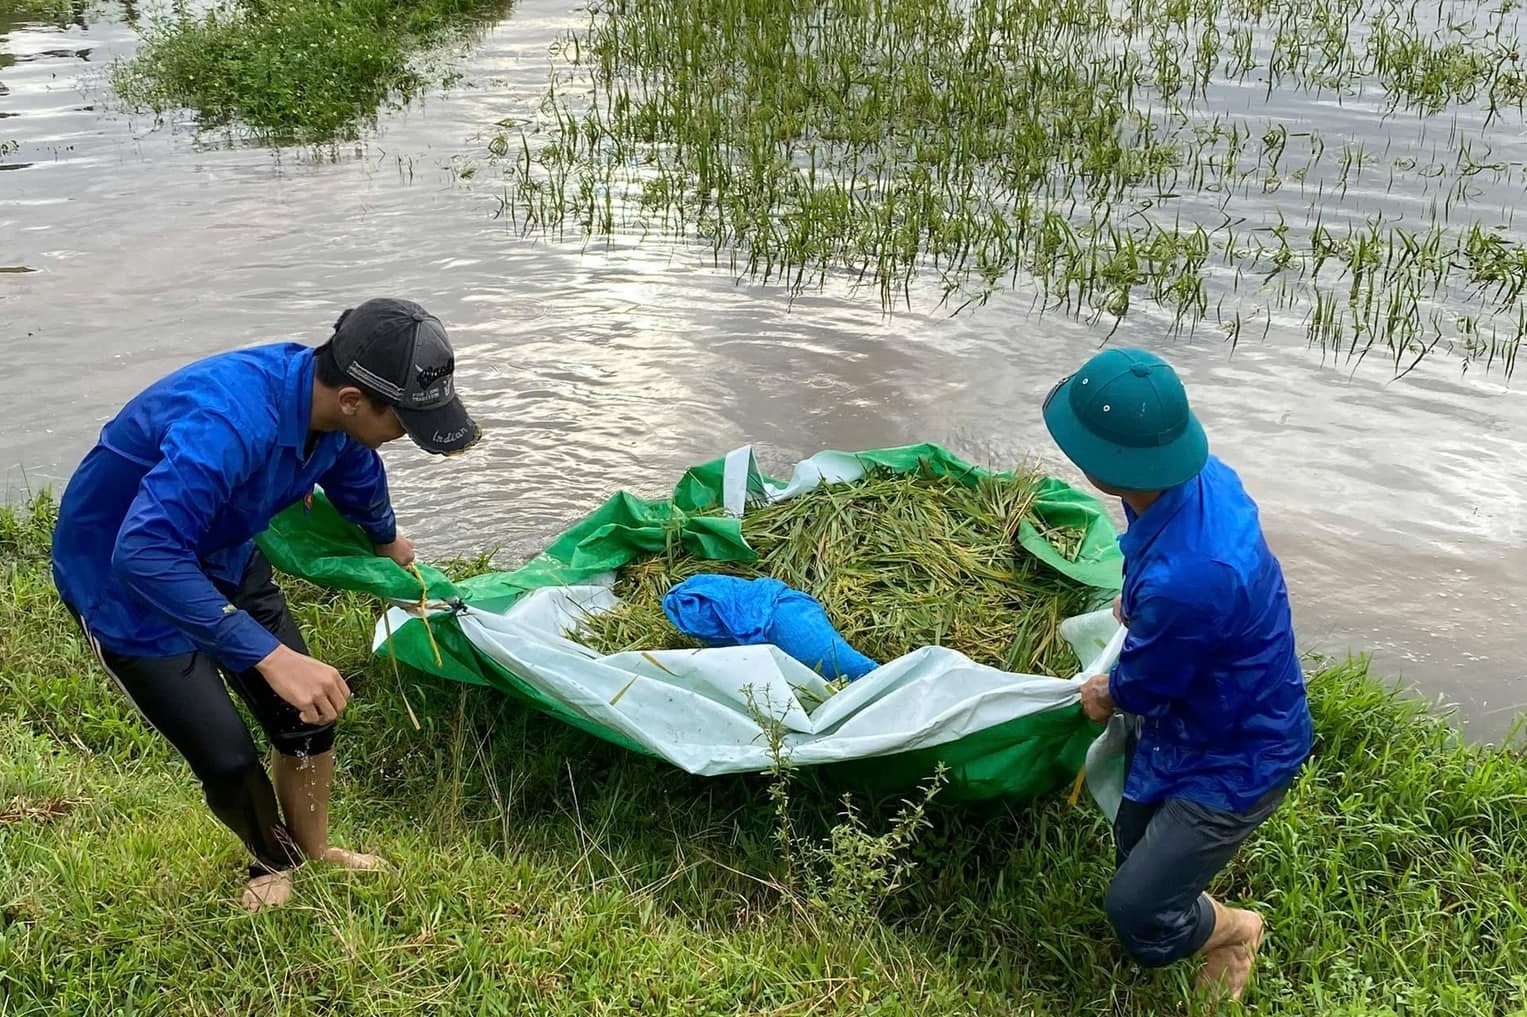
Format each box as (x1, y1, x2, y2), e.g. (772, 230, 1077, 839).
(0, 0, 1527, 738)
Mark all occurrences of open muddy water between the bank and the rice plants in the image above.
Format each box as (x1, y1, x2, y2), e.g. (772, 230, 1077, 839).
(0, 0, 1527, 739)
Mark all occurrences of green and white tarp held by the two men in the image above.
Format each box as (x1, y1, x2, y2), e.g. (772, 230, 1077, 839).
(260, 444, 1124, 815)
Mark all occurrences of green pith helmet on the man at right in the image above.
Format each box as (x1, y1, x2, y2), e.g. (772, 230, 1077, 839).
(1044, 348, 1209, 490)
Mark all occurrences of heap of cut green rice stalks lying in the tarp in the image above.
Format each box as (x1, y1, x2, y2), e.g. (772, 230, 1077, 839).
(574, 473, 1093, 676)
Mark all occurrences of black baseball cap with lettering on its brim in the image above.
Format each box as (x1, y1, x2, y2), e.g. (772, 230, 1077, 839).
(328, 296, 483, 455)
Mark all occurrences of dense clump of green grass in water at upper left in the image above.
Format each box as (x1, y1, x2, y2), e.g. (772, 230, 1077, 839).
(113, 0, 513, 145)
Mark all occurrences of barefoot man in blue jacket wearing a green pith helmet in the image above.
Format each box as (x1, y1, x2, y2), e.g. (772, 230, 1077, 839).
(1044, 350, 1312, 999)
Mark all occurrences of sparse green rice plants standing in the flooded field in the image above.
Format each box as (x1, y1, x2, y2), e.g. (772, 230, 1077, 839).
(490, 0, 1527, 374)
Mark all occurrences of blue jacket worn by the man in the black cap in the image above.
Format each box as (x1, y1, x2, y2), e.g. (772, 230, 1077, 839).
(53, 344, 397, 670)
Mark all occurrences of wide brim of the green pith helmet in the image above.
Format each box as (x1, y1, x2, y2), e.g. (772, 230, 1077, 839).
(1044, 379, 1209, 490)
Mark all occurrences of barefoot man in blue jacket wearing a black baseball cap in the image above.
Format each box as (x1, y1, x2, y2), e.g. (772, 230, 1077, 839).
(53, 299, 479, 910)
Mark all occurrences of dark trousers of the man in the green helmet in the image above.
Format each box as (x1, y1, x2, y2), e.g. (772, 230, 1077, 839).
(1104, 739, 1292, 968)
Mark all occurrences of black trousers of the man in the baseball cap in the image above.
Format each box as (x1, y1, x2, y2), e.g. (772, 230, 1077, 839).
(70, 551, 334, 875)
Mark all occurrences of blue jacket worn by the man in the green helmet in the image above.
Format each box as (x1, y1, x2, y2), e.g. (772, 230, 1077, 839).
(1109, 457, 1313, 812)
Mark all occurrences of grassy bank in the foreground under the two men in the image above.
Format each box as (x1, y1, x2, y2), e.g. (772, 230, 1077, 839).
(0, 488, 1527, 1017)
